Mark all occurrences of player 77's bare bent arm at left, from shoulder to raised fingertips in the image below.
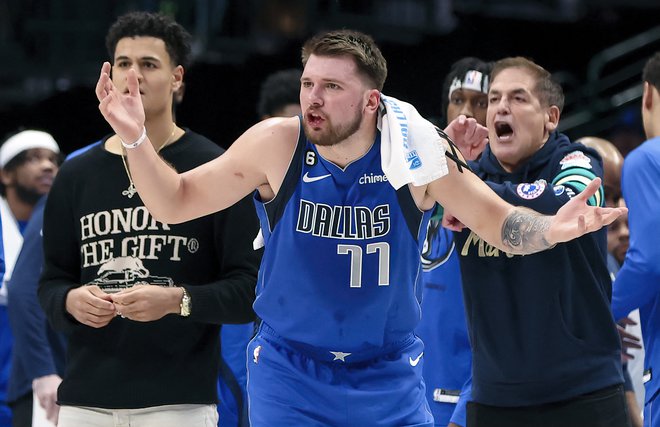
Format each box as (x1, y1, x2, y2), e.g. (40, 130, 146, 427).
(96, 62, 298, 223)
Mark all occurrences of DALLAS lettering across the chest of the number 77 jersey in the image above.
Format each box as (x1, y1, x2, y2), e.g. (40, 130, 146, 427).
(296, 199, 390, 240)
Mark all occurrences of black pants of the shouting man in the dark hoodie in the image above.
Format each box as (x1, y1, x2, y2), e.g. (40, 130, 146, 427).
(467, 385, 630, 427)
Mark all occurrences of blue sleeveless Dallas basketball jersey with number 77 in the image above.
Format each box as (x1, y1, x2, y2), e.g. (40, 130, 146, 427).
(254, 120, 431, 362)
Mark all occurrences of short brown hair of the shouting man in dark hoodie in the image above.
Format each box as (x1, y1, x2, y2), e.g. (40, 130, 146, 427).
(490, 56, 564, 112)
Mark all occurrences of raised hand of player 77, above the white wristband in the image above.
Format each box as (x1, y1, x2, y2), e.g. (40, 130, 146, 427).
(96, 62, 144, 143)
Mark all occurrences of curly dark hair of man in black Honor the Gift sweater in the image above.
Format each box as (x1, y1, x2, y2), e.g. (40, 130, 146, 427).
(105, 12, 192, 68)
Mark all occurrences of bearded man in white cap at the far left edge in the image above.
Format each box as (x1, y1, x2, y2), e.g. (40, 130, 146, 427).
(0, 130, 60, 426)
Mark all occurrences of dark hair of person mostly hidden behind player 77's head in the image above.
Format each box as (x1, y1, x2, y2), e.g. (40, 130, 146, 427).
(257, 68, 302, 117)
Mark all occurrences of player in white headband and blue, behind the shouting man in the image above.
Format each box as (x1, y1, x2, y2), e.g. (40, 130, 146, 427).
(416, 57, 490, 427)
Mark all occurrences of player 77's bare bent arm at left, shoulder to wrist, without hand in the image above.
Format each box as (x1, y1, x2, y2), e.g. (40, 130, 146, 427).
(128, 117, 298, 224)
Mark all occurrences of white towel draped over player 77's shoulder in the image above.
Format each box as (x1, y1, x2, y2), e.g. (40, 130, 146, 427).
(378, 94, 449, 190)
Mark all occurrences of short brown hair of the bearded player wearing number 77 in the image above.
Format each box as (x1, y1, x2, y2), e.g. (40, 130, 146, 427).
(302, 30, 387, 91)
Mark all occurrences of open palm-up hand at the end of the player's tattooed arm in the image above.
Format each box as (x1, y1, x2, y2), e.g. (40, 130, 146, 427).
(546, 178, 628, 244)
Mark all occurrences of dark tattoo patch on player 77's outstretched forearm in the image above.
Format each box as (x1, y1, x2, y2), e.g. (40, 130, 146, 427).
(502, 209, 552, 254)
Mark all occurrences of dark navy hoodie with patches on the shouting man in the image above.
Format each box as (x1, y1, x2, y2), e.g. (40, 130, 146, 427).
(456, 133, 623, 406)
